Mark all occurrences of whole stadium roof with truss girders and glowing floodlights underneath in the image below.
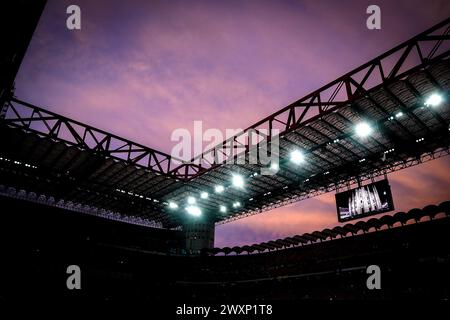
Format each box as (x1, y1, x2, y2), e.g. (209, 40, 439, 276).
(0, 19, 450, 228)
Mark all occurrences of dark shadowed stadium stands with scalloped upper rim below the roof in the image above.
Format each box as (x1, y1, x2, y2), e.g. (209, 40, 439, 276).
(0, 197, 450, 302)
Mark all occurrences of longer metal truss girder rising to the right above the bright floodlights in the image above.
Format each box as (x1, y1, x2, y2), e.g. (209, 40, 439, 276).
(169, 18, 450, 179)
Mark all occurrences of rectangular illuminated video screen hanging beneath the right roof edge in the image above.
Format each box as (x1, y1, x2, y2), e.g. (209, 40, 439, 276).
(336, 179, 394, 222)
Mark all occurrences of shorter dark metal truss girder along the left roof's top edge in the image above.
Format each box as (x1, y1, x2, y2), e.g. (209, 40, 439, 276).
(0, 97, 198, 180)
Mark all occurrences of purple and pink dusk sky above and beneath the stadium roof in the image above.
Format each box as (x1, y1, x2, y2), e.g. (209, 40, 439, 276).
(16, 0, 450, 246)
